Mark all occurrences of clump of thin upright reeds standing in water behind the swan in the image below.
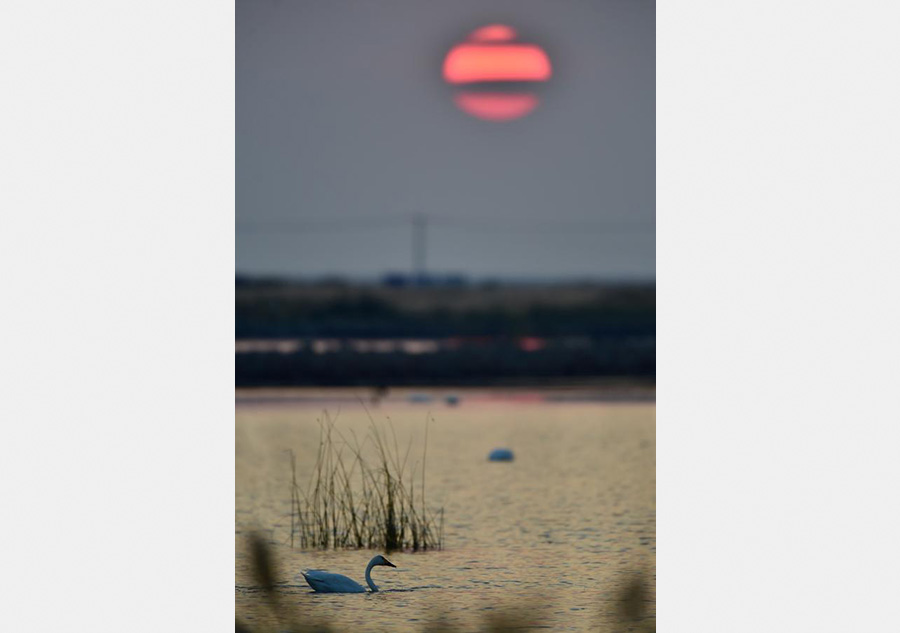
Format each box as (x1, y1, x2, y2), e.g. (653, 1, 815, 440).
(290, 411, 444, 552)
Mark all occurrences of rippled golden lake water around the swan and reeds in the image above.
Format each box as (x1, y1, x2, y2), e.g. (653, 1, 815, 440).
(235, 390, 656, 631)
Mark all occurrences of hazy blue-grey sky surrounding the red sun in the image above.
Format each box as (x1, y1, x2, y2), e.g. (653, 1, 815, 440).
(236, 0, 656, 279)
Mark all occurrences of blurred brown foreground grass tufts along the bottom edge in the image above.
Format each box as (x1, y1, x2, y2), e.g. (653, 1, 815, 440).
(235, 534, 656, 633)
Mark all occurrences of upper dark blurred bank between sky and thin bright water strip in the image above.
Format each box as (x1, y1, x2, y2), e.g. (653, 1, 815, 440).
(235, 278, 656, 339)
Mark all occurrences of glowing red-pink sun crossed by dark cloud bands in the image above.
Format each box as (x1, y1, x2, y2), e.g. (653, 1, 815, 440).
(443, 24, 553, 121)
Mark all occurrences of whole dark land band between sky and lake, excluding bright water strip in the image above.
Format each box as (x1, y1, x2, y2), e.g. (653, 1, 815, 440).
(235, 278, 656, 386)
